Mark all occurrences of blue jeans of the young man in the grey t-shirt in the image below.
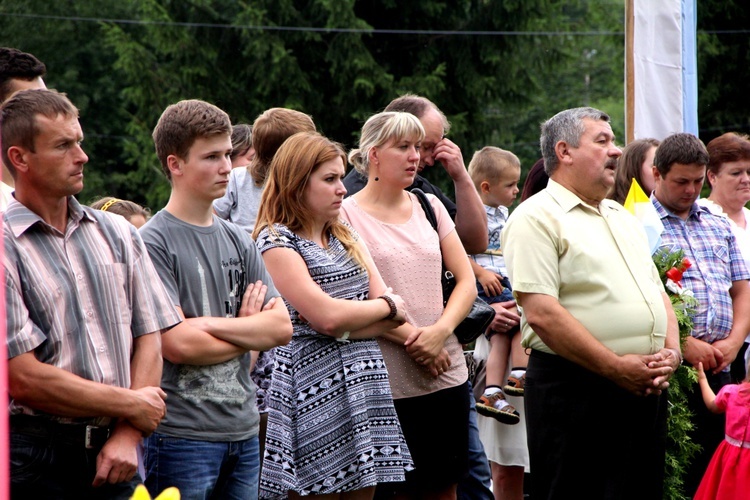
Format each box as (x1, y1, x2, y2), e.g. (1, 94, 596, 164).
(143, 433, 260, 500)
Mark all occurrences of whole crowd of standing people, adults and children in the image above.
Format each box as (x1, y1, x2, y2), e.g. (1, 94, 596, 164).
(0, 44, 750, 500)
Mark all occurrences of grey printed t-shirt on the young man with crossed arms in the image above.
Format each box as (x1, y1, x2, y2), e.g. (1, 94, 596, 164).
(140, 210, 279, 441)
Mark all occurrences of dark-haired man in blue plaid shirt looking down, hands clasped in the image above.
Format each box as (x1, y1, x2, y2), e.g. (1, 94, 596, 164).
(651, 133, 750, 496)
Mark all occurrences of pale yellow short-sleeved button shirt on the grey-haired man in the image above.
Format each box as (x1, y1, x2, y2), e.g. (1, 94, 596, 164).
(502, 180, 667, 355)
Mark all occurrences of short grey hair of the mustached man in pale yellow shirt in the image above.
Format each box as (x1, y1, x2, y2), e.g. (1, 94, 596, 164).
(539, 108, 609, 175)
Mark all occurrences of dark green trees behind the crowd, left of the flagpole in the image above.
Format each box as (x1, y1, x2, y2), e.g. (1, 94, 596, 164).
(0, 0, 624, 210)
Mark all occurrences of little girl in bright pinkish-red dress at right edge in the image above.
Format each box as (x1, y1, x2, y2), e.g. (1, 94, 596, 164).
(695, 363, 750, 500)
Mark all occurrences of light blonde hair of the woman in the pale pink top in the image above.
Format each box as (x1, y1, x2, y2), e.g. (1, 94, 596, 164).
(349, 111, 424, 176)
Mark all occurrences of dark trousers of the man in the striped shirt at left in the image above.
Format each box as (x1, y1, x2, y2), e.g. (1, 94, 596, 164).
(10, 432, 141, 500)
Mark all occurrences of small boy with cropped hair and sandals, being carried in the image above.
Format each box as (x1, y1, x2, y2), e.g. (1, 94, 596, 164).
(469, 146, 528, 424)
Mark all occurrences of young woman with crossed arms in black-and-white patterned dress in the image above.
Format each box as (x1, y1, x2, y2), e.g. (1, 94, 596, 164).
(254, 132, 412, 500)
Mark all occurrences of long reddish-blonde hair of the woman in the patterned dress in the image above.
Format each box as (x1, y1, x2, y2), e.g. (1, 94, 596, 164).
(253, 132, 365, 268)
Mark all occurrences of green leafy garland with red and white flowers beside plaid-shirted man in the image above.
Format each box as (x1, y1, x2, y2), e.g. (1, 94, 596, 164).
(653, 247, 699, 500)
